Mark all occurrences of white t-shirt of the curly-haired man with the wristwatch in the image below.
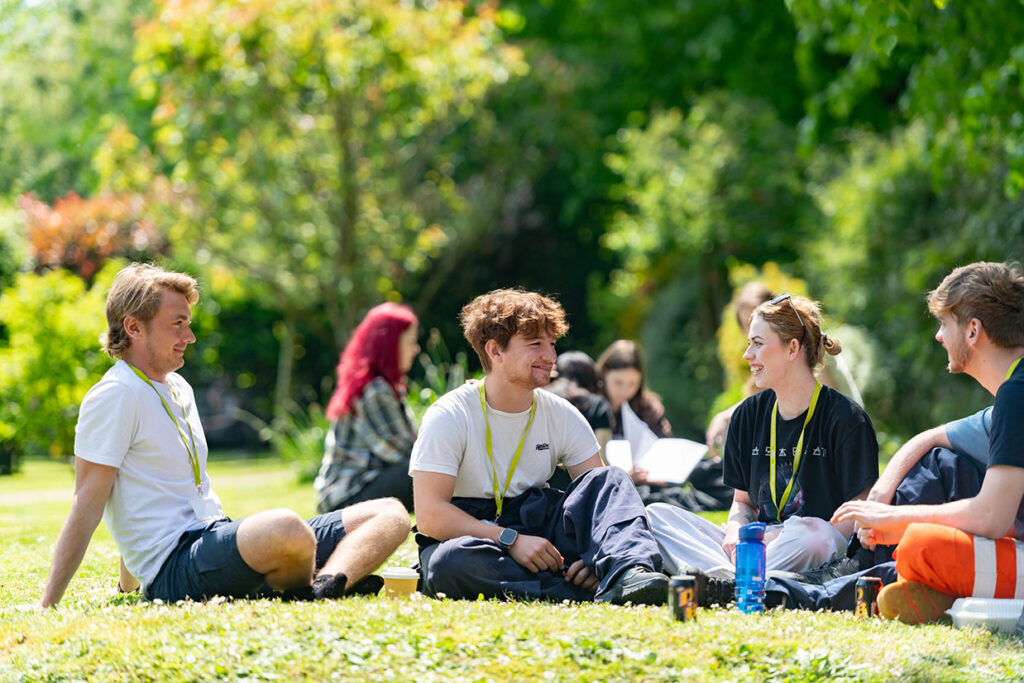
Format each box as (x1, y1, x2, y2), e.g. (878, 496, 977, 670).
(409, 381, 599, 500)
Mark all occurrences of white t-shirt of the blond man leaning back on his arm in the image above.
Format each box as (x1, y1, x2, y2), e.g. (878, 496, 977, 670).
(75, 360, 219, 591)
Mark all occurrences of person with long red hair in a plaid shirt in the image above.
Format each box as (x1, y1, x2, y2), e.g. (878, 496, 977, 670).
(313, 303, 420, 513)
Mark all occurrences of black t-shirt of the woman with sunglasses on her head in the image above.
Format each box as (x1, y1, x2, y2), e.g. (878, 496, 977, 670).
(725, 386, 879, 522)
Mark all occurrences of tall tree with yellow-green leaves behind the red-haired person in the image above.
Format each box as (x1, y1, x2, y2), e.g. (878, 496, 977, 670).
(103, 0, 520, 417)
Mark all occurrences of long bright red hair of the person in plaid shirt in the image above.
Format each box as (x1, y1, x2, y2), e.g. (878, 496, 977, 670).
(327, 303, 416, 420)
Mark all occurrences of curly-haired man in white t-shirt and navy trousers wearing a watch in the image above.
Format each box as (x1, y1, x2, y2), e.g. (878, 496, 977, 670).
(410, 290, 668, 604)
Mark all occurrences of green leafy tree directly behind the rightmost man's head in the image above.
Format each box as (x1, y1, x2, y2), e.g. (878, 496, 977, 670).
(804, 123, 1024, 433)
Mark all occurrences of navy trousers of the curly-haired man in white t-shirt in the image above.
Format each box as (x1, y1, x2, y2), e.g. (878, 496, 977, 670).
(416, 467, 662, 601)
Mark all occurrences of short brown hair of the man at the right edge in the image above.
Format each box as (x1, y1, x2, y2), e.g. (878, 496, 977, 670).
(928, 261, 1024, 348)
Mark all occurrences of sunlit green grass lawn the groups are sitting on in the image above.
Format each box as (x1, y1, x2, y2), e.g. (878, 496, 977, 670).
(0, 460, 1024, 682)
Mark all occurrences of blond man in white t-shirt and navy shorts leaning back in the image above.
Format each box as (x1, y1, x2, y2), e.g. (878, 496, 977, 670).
(40, 263, 410, 607)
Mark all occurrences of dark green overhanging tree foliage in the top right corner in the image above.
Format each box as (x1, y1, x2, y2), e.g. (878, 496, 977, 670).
(786, 0, 1024, 197)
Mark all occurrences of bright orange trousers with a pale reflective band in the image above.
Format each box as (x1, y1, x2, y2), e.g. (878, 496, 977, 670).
(894, 523, 1024, 600)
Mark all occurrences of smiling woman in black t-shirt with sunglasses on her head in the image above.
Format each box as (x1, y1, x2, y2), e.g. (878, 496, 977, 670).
(647, 294, 879, 589)
